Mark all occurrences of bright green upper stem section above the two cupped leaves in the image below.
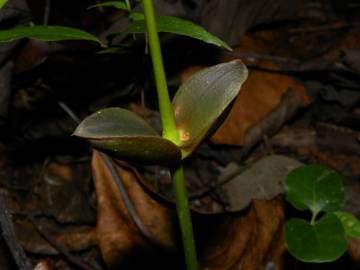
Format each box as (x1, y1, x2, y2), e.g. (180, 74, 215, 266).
(143, 0, 179, 143)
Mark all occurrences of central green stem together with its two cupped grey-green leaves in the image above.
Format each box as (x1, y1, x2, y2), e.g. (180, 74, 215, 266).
(74, 12, 247, 270)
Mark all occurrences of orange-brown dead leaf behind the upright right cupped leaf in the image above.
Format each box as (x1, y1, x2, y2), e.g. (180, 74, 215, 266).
(211, 70, 309, 145)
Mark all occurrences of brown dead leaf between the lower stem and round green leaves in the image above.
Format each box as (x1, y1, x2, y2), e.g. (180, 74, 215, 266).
(199, 200, 284, 270)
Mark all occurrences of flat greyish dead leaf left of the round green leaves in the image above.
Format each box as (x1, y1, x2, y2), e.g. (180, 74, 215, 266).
(187, 155, 302, 214)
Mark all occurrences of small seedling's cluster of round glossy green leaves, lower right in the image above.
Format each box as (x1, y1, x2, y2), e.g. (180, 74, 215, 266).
(285, 165, 360, 262)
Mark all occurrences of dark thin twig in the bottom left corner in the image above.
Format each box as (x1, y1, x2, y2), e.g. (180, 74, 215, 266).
(0, 194, 32, 270)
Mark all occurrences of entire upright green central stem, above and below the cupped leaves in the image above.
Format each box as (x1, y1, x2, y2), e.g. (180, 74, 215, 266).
(142, 0, 198, 270)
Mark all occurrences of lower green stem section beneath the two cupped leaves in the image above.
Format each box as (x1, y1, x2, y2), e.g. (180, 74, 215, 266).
(172, 165, 198, 270)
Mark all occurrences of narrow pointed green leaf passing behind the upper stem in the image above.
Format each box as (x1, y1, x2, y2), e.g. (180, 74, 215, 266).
(122, 16, 231, 51)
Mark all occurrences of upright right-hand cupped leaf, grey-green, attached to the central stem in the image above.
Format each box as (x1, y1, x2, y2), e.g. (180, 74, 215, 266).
(173, 60, 248, 158)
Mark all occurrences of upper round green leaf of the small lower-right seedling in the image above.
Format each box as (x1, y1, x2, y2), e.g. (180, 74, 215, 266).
(285, 165, 344, 215)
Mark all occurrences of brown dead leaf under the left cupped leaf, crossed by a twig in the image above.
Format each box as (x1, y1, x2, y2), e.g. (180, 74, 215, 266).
(92, 151, 175, 268)
